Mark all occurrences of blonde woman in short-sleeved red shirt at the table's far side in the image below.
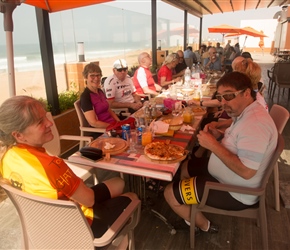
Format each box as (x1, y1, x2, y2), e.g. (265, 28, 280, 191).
(157, 53, 181, 89)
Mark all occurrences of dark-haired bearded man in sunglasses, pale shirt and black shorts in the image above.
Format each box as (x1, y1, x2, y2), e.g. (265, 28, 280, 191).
(164, 72, 278, 233)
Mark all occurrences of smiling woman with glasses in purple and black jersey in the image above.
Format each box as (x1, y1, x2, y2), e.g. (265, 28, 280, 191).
(80, 63, 120, 128)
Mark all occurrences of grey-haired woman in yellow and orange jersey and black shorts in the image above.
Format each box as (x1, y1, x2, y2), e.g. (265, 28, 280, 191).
(0, 96, 138, 244)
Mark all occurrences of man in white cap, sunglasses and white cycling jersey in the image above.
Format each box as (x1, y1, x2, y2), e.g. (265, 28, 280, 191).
(104, 59, 143, 114)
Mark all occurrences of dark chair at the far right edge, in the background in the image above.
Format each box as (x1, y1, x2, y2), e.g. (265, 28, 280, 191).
(272, 62, 290, 104)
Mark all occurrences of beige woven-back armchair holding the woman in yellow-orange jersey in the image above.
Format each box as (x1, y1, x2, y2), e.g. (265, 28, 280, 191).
(1, 183, 141, 250)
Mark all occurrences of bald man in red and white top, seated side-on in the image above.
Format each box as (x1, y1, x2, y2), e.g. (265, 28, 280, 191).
(133, 52, 161, 96)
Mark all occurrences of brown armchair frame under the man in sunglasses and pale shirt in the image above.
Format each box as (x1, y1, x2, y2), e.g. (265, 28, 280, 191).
(190, 134, 284, 250)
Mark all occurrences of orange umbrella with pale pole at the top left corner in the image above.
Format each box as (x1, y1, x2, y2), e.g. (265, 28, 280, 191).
(0, 0, 114, 96)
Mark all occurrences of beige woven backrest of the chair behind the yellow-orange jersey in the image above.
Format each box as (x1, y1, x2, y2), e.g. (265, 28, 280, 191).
(1, 184, 94, 250)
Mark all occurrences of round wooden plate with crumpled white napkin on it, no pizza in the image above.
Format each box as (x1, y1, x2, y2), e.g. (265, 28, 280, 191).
(89, 138, 128, 155)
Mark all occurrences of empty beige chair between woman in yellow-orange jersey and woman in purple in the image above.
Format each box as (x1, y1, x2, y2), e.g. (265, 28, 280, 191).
(43, 112, 98, 184)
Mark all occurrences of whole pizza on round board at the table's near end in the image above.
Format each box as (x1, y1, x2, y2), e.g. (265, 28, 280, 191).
(144, 142, 185, 161)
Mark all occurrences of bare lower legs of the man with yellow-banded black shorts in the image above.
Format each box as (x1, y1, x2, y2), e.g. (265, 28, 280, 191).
(164, 183, 209, 231)
